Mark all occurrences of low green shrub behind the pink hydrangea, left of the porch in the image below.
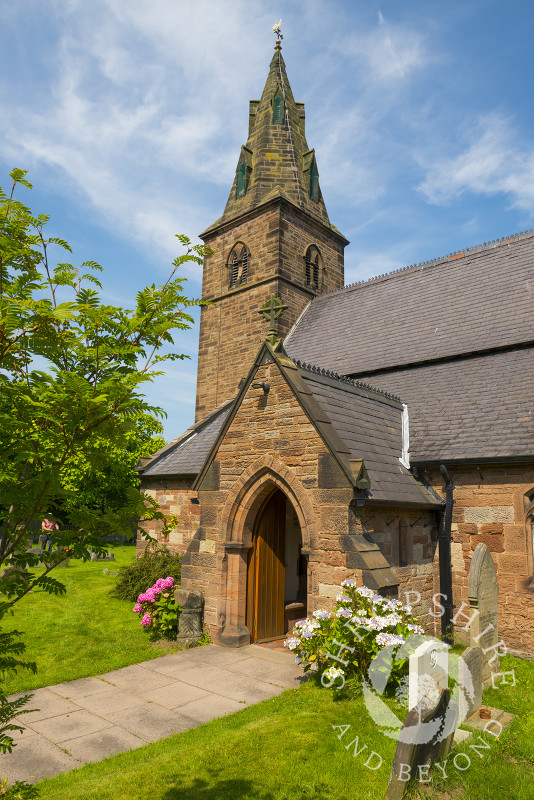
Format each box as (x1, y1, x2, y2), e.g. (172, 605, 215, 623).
(111, 544, 182, 603)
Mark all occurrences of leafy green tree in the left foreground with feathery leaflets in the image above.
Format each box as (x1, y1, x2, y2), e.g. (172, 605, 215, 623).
(0, 169, 206, 752)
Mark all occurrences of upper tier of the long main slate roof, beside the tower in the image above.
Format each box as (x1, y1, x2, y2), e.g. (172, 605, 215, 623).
(285, 232, 534, 382)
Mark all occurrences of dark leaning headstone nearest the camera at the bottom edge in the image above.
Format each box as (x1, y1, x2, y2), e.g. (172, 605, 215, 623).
(386, 689, 458, 800)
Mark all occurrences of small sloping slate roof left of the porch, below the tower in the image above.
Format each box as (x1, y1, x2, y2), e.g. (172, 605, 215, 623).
(141, 400, 232, 478)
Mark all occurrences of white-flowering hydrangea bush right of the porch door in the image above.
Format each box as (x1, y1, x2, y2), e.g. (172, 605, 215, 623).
(284, 580, 424, 689)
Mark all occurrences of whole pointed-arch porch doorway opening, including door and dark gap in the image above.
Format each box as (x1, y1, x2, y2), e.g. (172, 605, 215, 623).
(246, 489, 307, 642)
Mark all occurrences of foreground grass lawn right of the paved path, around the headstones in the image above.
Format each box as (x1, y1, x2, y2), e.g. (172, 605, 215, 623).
(32, 657, 534, 800)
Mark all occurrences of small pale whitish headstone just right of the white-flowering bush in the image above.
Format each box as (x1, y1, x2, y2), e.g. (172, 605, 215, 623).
(408, 639, 449, 709)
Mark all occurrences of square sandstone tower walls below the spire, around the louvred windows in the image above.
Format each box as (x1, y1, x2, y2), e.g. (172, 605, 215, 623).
(196, 202, 343, 420)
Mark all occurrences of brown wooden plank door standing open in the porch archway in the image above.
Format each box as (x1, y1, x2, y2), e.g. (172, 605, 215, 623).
(247, 490, 286, 642)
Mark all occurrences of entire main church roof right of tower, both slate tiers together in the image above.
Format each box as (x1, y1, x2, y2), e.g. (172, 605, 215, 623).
(285, 231, 534, 462)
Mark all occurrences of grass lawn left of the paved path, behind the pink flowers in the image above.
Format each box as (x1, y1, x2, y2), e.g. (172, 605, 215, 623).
(2, 546, 186, 694)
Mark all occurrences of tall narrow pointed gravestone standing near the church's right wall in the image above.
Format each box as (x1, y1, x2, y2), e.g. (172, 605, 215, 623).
(467, 542, 500, 687)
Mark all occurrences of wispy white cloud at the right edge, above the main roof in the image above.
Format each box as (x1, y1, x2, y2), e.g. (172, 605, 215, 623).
(418, 112, 534, 214)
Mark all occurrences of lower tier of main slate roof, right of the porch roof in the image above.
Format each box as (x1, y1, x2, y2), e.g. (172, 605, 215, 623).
(372, 347, 534, 462)
